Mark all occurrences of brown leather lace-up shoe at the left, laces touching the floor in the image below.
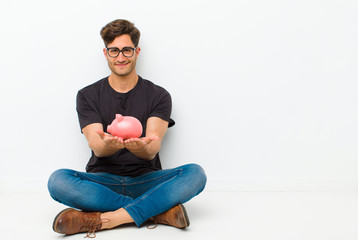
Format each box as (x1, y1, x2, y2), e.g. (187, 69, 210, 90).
(52, 208, 102, 238)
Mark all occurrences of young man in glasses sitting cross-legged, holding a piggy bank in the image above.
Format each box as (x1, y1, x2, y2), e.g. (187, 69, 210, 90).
(48, 20, 206, 237)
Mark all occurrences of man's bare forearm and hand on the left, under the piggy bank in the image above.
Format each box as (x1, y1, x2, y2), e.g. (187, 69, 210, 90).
(82, 123, 124, 157)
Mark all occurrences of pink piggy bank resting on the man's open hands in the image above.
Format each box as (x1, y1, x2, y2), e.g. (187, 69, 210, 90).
(107, 114, 143, 139)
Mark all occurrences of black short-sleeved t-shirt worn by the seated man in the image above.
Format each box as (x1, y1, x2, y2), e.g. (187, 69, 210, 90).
(77, 77, 175, 177)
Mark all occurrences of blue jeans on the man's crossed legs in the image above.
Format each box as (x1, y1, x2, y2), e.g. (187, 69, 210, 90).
(48, 164, 206, 226)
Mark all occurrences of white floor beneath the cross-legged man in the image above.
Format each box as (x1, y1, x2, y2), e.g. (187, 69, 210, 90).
(0, 192, 358, 240)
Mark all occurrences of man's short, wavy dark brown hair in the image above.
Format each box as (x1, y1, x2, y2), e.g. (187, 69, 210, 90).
(101, 19, 140, 47)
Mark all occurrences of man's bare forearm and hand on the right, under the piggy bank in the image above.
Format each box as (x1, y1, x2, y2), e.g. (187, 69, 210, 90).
(124, 117, 168, 160)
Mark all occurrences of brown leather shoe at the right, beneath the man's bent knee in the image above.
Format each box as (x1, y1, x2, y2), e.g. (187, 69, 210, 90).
(152, 204, 190, 228)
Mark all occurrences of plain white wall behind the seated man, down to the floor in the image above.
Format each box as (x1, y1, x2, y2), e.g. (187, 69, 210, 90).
(0, 0, 358, 191)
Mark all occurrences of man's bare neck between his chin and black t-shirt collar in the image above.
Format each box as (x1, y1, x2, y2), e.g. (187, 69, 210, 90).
(108, 71, 138, 93)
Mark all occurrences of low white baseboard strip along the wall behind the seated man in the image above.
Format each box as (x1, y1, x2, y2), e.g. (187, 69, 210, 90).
(0, 178, 358, 192)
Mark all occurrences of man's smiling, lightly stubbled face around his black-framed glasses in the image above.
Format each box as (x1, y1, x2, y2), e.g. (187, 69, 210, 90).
(103, 34, 140, 76)
